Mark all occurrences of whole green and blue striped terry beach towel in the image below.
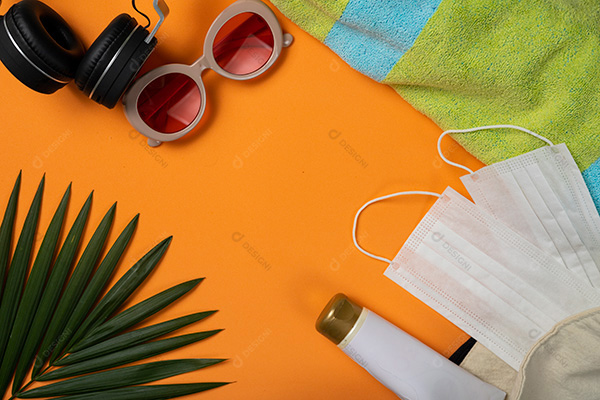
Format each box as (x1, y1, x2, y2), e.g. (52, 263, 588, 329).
(272, 0, 600, 207)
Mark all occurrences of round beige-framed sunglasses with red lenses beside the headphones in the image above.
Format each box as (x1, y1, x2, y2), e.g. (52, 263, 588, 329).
(123, 0, 294, 147)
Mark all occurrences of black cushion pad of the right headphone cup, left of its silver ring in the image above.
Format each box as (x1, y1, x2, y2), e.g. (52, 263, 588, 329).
(75, 14, 137, 95)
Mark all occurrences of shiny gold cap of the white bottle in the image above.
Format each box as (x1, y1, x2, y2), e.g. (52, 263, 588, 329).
(316, 293, 363, 345)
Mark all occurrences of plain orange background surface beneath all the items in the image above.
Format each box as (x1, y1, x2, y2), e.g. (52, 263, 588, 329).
(0, 0, 480, 400)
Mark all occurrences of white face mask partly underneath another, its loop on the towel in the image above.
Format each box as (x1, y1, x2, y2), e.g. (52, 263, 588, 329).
(438, 125, 600, 288)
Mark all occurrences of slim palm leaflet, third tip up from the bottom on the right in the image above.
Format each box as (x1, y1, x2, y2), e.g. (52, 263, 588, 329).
(37, 329, 222, 382)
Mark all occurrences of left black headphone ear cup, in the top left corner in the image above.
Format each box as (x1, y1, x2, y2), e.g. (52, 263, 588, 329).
(0, 0, 85, 94)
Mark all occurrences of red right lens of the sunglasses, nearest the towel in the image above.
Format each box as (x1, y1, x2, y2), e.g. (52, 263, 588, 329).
(213, 12, 275, 75)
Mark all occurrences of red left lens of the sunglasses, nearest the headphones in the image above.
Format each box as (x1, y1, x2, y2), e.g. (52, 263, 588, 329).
(137, 73, 202, 133)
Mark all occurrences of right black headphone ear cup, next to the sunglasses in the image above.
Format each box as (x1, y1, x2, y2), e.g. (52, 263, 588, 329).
(75, 14, 157, 108)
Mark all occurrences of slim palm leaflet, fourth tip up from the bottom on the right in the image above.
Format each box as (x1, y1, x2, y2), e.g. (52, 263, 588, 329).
(54, 311, 216, 366)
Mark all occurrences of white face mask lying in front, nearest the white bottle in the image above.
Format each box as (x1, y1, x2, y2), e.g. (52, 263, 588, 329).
(353, 188, 600, 369)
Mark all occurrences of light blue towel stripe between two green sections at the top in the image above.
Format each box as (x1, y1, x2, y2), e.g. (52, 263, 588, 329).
(325, 0, 441, 82)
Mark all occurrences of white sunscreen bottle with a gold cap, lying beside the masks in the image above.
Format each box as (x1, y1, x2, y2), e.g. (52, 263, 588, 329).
(316, 293, 506, 400)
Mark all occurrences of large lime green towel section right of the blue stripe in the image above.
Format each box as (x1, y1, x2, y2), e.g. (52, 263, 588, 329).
(384, 0, 600, 170)
